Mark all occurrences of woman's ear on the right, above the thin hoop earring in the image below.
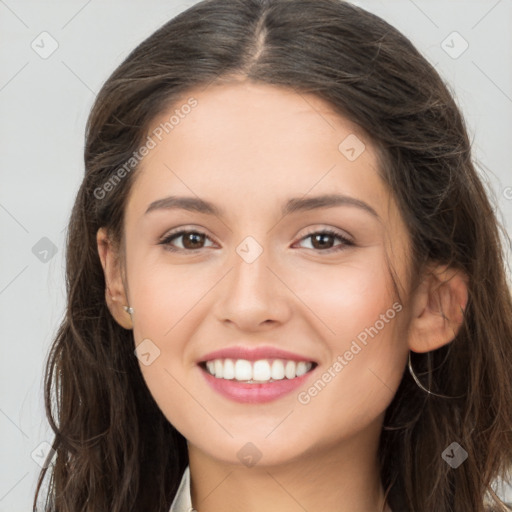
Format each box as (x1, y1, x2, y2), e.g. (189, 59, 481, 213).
(408, 265, 469, 352)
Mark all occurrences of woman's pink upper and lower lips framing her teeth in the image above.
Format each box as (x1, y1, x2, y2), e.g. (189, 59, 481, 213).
(198, 346, 316, 404)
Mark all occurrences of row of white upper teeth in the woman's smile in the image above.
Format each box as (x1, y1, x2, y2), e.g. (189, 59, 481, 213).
(206, 359, 313, 382)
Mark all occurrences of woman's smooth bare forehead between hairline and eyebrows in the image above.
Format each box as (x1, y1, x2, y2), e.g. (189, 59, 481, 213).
(130, 81, 389, 222)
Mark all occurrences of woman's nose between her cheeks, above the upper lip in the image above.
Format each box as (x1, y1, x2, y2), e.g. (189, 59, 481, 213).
(214, 243, 293, 331)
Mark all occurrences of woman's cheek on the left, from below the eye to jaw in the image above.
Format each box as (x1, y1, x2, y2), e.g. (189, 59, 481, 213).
(128, 258, 217, 435)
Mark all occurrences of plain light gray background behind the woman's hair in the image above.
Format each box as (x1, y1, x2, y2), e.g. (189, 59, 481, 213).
(0, 0, 512, 512)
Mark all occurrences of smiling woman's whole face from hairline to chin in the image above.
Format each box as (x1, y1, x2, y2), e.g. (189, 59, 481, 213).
(119, 82, 409, 465)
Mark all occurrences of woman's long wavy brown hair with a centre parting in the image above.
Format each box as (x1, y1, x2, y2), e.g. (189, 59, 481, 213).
(34, 0, 512, 512)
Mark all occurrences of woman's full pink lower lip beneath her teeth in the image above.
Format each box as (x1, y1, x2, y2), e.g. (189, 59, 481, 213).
(200, 368, 315, 404)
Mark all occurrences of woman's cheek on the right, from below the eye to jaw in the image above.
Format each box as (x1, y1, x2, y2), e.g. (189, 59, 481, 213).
(292, 251, 408, 420)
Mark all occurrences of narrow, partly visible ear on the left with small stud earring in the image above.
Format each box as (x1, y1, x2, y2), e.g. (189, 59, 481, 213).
(96, 228, 133, 329)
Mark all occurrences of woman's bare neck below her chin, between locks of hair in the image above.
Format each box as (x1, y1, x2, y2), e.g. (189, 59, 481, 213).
(188, 414, 389, 512)
